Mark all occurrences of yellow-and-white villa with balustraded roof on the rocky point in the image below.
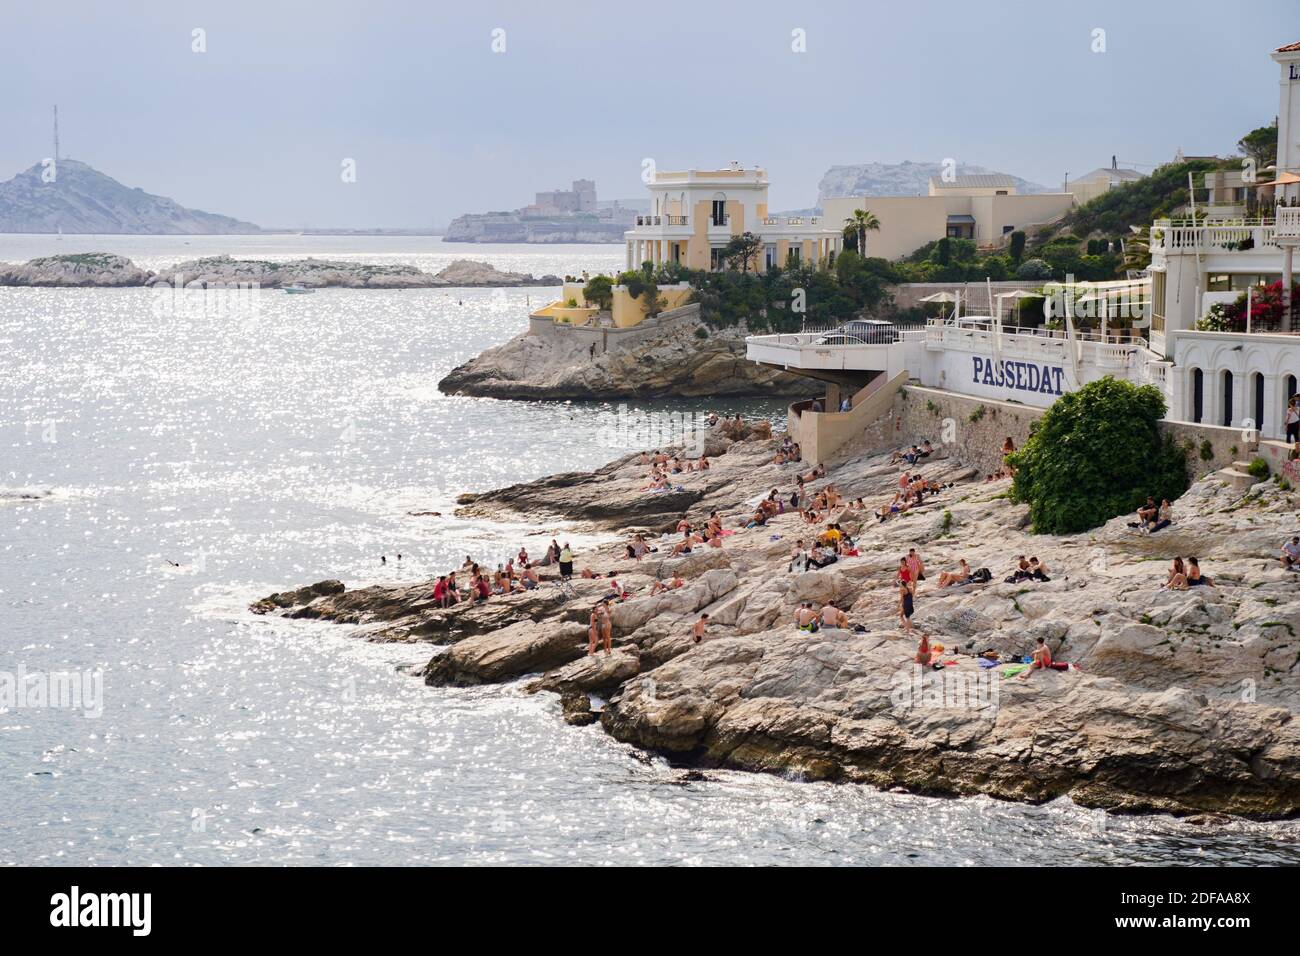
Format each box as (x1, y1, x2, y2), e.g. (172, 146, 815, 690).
(625, 163, 844, 272)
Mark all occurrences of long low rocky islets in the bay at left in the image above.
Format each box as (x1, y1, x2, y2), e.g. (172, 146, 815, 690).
(0, 252, 560, 289)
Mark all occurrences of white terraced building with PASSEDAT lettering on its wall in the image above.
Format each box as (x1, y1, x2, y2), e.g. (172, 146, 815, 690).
(746, 43, 1300, 470)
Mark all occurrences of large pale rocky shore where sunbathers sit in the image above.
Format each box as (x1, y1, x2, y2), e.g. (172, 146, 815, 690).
(255, 424, 1300, 817)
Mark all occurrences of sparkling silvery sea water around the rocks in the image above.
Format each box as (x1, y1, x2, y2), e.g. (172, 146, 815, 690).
(0, 235, 1300, 865)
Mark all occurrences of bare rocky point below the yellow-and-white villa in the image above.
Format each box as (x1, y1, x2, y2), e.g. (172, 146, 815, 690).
(438, 306, 809, 401)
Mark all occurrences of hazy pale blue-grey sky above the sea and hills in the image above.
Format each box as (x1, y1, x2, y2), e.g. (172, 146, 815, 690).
(0, 0, 1300, 228)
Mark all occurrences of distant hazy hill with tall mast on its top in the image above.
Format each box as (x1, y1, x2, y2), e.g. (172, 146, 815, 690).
(0, 159, 261, 235)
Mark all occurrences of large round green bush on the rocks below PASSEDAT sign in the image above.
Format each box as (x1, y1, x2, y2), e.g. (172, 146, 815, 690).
(1008, 376, 1187, 535)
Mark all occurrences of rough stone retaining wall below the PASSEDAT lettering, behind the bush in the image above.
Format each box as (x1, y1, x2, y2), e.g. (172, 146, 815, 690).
(865, 385, 1256, 479)
